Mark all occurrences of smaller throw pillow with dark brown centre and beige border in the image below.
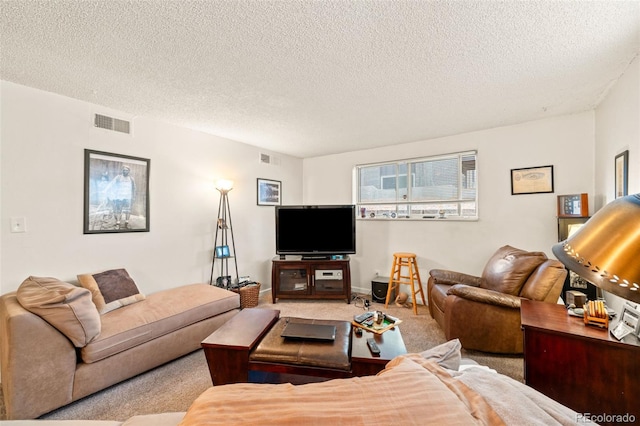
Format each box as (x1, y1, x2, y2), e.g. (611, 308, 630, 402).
(78, 269, 145, 314)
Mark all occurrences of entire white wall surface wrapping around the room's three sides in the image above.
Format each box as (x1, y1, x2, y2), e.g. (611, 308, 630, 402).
(0, 55, 640, 302)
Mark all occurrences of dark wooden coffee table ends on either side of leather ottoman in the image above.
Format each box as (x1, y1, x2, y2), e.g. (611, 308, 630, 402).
(202, 308, 407, 385)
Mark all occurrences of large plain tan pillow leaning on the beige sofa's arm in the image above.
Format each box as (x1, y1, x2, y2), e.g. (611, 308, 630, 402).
(16, 277, 100, 348)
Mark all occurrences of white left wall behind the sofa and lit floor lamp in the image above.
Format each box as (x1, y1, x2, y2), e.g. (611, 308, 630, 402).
(0, 82, 302, 293)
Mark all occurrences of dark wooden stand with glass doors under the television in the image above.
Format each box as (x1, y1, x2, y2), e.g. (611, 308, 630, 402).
(271, 256, 351, 303)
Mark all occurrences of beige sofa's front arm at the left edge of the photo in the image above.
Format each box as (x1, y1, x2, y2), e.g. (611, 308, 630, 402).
(0, 292, 76, 420)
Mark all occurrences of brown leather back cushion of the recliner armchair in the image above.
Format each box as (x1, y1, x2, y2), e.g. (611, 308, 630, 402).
(480, 245, 547, 296)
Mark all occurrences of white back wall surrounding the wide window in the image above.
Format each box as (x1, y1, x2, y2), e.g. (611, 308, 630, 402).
(303, 112, 594, 291)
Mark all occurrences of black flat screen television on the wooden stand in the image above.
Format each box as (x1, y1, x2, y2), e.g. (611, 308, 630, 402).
(276, 205, 356, 258)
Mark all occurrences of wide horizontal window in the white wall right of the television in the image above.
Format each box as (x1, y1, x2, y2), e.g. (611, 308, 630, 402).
(355, 151, 478, 219)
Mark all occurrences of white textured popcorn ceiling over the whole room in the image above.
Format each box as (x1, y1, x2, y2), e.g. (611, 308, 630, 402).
(0, 0, 640, 157)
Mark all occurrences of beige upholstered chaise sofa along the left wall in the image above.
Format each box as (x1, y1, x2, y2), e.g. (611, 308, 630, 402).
(0, 277, 240, 420)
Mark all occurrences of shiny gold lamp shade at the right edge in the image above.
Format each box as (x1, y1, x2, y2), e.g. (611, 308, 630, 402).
(552, 194, 640, 303)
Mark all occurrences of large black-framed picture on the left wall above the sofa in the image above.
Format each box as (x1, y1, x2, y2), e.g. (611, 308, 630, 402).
(84, 149, 150, 234)
